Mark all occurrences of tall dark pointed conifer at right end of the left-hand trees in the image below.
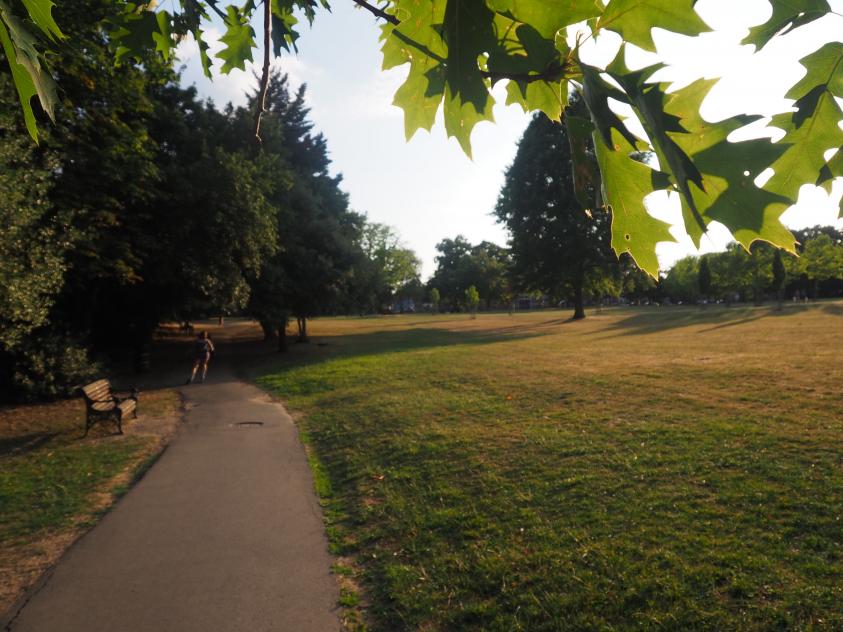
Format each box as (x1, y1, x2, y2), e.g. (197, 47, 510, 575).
(240, 72, 363, 342)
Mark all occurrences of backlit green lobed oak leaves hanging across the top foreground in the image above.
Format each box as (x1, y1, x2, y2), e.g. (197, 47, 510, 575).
(0, 0, 843, 276)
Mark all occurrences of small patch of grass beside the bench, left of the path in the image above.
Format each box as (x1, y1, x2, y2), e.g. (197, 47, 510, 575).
(0, 390, 180, 614)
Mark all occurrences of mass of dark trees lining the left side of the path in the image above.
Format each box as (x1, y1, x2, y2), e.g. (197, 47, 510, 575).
(0, 0, 421, 401)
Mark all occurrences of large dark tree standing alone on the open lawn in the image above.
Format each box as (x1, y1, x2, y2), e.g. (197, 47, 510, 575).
(495, 108, 618, 319)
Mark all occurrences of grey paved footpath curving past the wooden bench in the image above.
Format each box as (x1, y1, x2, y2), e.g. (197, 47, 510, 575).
(7, 366, 340, 632)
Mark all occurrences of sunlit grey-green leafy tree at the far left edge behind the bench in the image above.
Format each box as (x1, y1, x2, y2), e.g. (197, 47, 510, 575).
(0, 75, 96, 401)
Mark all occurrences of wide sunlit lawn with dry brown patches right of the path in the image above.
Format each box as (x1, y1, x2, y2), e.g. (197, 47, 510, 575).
(260, 303, 843, 631)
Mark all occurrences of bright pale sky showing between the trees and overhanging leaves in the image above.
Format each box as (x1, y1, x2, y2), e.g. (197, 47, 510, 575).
(179, 0, 843, 278)
